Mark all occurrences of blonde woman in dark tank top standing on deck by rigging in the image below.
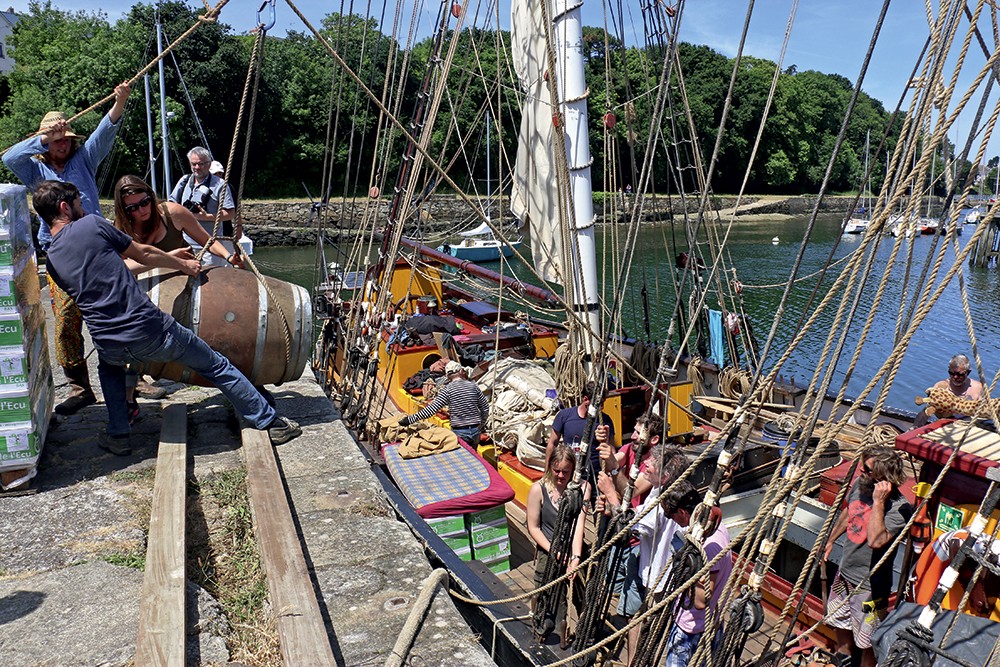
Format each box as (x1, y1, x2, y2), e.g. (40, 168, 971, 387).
(527, 445, 590, 647)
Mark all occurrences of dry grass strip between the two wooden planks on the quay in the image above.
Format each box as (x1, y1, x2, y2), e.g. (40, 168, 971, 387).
(187, 468, 282, 666)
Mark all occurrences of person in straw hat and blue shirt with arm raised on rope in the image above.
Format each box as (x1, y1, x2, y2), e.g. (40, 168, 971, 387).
(3, 81, 137, 415)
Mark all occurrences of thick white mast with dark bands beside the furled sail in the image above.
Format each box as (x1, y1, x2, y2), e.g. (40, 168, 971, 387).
(553, 0, 603, 359)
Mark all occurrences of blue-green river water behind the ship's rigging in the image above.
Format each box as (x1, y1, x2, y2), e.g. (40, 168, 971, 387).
(254, 211, 1000, 411)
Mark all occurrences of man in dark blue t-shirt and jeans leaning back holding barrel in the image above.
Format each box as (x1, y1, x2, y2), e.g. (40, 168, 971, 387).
(32, 181, 302, 456)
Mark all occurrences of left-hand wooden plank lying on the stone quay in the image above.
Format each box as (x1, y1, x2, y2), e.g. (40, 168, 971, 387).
(135, 404, 187, 667)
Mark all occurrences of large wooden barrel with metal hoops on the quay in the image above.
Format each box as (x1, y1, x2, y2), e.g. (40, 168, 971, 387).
(139, 267, 312, 385)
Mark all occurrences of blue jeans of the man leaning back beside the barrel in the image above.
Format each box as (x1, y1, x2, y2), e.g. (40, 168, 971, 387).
(97, 322, 277, 436)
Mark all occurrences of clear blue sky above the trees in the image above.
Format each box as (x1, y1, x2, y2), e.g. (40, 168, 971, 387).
(13, 0, 1000, 158)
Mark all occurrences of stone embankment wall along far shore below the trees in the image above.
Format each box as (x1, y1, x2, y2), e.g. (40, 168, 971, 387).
(243, 195, 853, 247)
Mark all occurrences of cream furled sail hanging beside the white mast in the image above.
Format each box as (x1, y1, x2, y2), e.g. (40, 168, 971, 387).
(510, 0, 566, 285)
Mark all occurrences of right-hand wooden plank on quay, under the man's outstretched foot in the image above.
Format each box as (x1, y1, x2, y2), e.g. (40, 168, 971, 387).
(243, 428, 337, 667)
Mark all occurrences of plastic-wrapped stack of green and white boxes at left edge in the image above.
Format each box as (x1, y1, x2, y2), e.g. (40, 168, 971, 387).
(0, 185, 55, 489)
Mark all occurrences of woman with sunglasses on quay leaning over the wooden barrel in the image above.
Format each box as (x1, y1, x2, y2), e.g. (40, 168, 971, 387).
(114, 176, 243, 273)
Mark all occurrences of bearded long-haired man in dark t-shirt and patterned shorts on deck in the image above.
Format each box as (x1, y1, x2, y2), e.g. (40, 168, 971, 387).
(824, 446, 913, 667)
